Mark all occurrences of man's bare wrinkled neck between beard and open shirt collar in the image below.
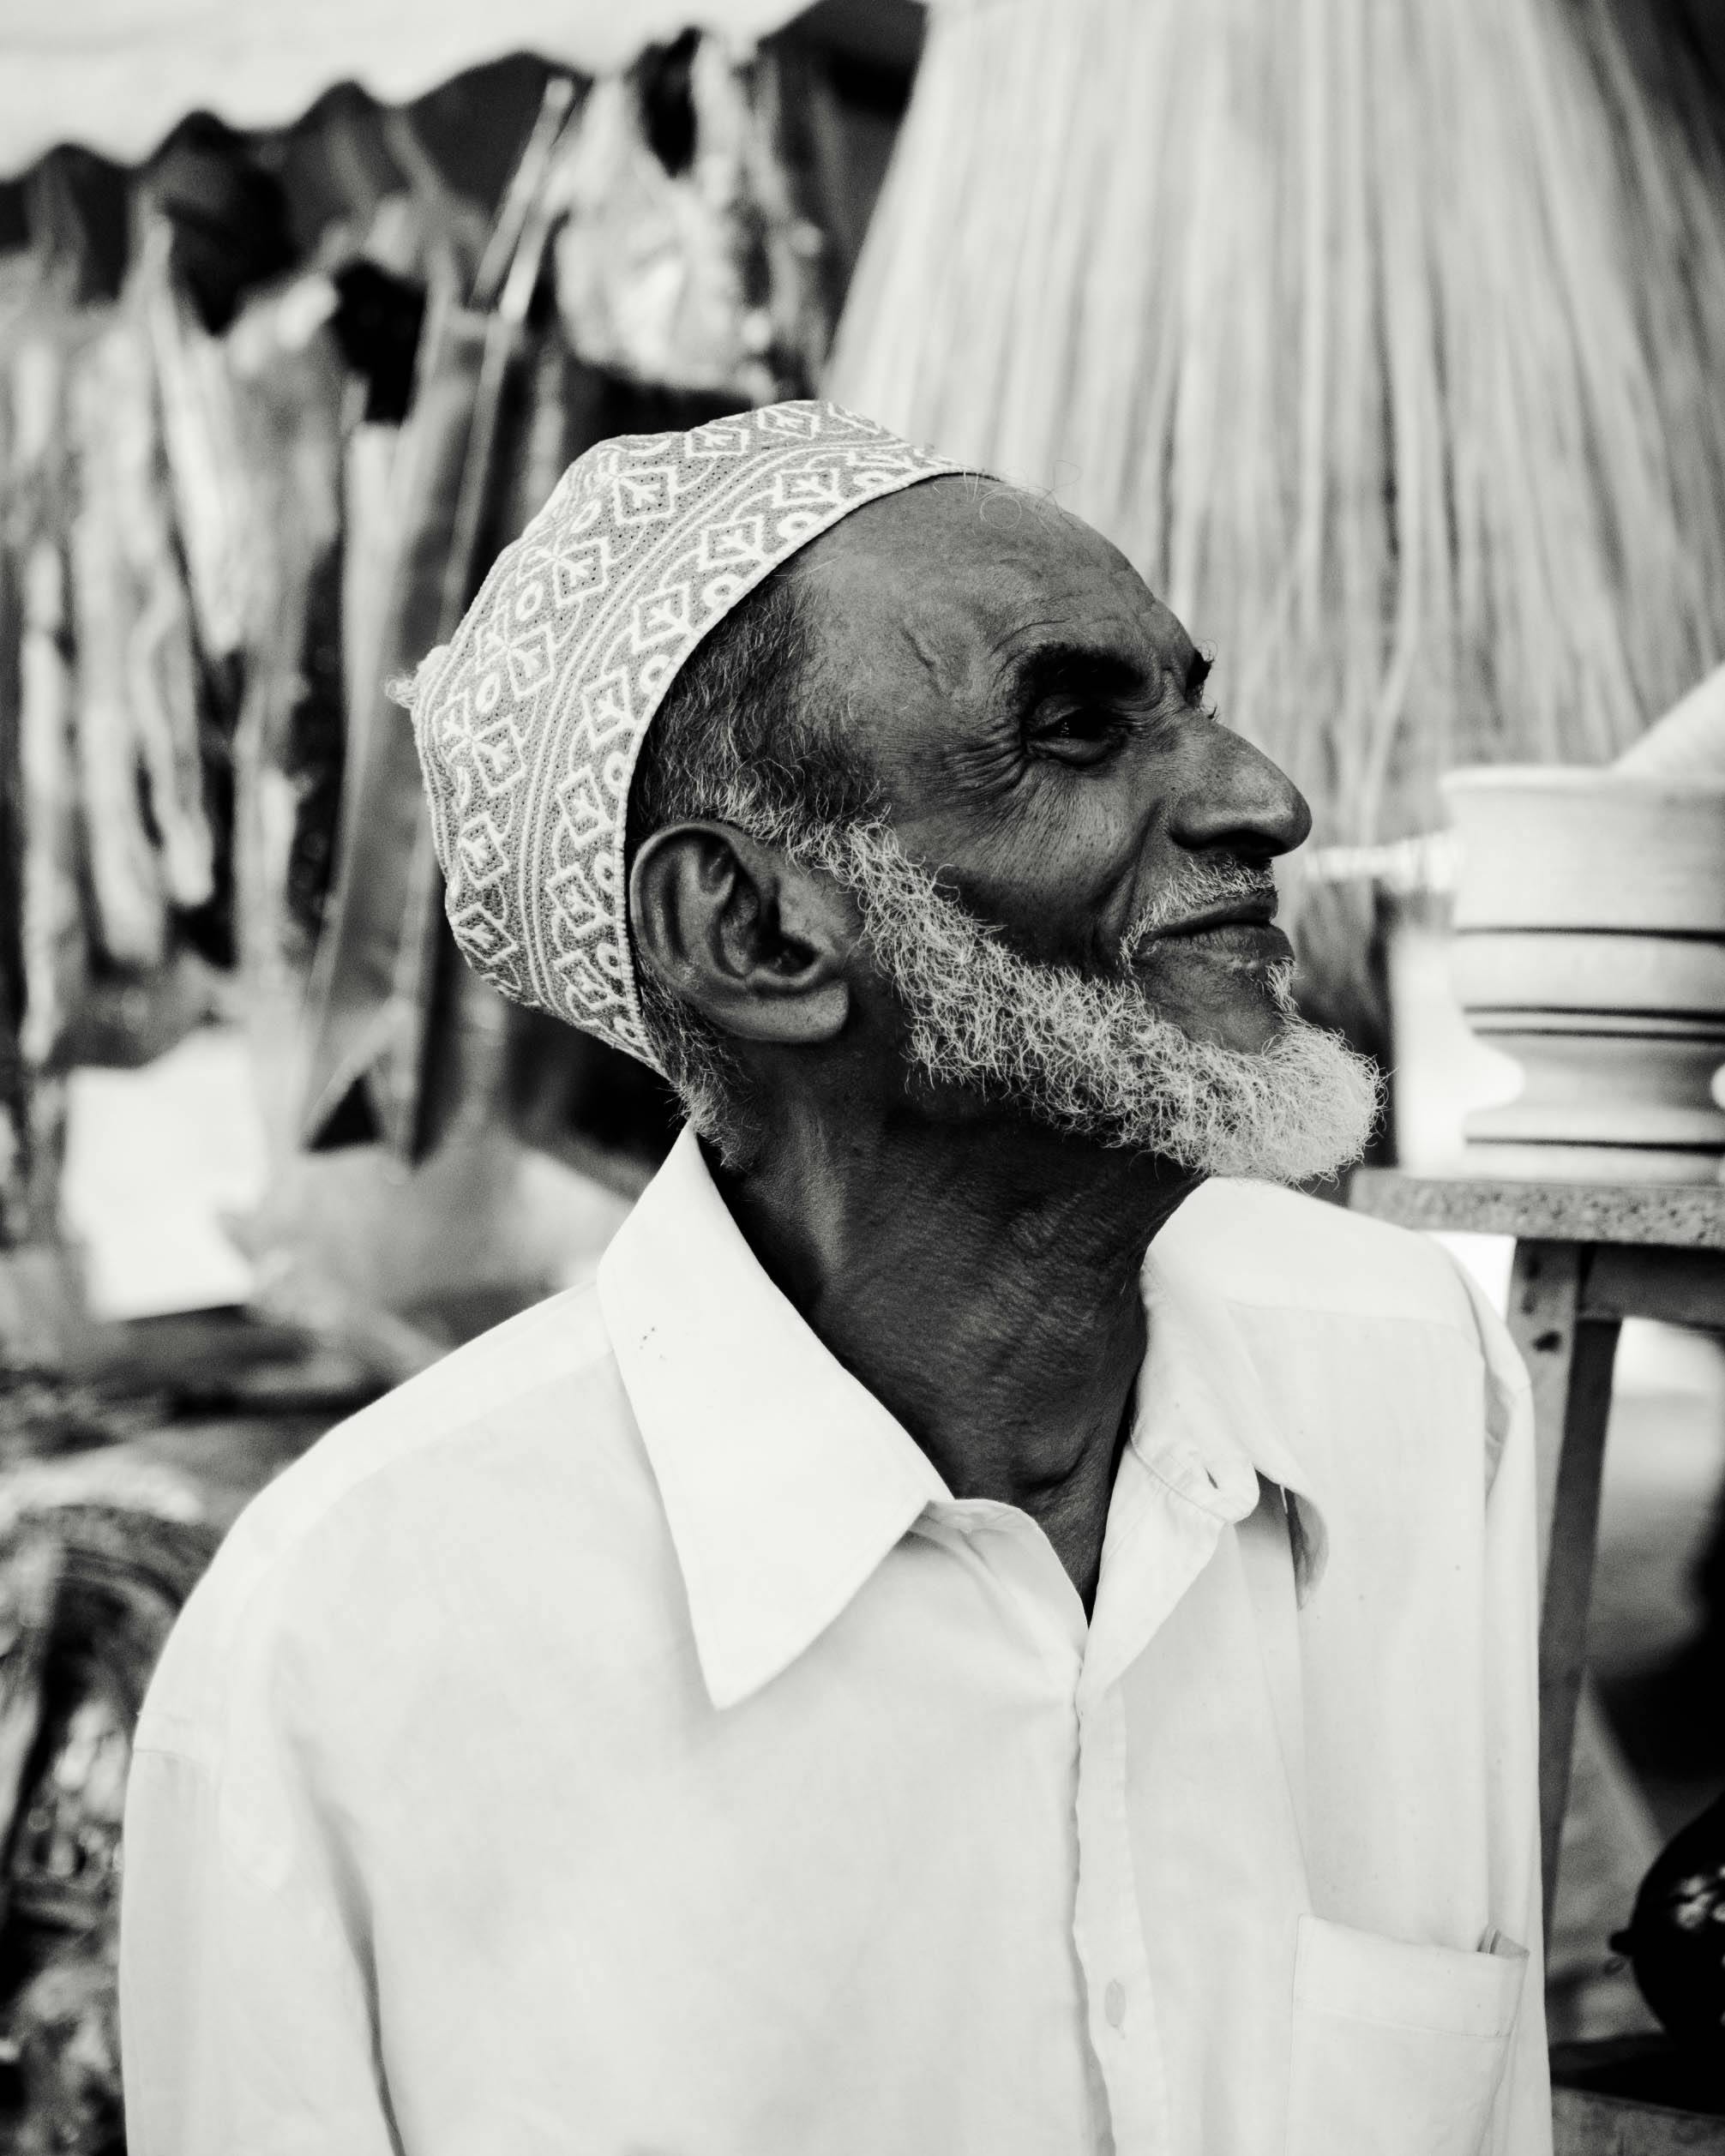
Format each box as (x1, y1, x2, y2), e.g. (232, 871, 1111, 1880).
(720, 1123, 1194, 1612)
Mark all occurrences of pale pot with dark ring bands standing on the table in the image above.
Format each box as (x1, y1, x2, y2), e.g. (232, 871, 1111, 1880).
(1443, 766, 1725, 1181)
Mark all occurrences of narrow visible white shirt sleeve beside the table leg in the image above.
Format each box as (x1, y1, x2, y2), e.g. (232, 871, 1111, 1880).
(1464, 1274, 1553, 2156)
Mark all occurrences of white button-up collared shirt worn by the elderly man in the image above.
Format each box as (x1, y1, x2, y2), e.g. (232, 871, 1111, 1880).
(121, 1136, 1550, 2156)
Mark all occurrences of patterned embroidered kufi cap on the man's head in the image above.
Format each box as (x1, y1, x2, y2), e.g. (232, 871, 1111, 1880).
(403, 403, 958, 1067)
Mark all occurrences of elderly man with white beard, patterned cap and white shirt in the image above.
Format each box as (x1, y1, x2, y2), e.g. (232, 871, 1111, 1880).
(123, 403, 1550, 2156)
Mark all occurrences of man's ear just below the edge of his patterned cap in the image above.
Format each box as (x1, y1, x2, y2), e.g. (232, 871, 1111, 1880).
(629, 824, 858, 1046)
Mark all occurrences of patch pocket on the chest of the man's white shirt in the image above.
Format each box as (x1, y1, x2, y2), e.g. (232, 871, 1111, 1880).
(1287, 1917, 1527, 2156)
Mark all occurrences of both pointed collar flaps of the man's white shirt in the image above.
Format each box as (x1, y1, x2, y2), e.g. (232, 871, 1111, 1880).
(598, 1130, 1324, 1708)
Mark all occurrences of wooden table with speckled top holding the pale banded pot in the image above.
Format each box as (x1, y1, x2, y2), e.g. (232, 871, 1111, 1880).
(1349, 1168, 1725, 2156)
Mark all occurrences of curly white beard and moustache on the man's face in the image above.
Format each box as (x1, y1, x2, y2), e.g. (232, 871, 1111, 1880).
(814, 824, 1382, 1184)
